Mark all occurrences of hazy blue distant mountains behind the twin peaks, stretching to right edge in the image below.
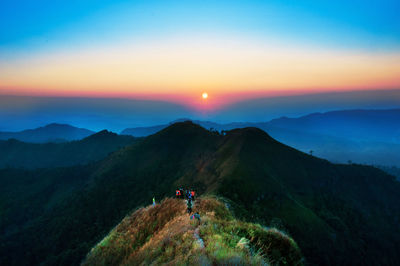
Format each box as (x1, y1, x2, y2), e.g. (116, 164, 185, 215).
(121, 109, 400, 167)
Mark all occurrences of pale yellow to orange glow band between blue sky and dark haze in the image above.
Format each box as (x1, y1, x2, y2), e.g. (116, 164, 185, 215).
(0, 36, 400, 110)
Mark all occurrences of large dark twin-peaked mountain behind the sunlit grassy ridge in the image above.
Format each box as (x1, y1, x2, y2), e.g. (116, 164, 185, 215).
(0, 122, 400, 265)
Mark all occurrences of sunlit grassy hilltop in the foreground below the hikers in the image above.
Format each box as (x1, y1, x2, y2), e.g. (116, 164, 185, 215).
(83, 197, 304, 265)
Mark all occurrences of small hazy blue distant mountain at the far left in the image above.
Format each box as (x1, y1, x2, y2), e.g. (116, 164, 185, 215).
(0, 123, 94, 143)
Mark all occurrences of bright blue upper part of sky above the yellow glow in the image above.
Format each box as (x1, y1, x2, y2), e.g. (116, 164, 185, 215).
(0, 0, 400, 53)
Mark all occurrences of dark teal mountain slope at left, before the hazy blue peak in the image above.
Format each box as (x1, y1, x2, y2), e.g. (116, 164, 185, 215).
(0, 130, 135, 169)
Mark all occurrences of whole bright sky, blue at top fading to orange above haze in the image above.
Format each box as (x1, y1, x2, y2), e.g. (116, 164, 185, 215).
(0, 0, 400, 128)
